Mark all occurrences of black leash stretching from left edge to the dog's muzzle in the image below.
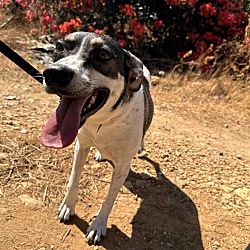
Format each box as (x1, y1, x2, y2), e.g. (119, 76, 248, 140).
(0, 40, 43, 84)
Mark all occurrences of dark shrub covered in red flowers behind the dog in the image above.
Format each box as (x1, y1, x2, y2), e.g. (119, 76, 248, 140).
(0, 0, 250, 68)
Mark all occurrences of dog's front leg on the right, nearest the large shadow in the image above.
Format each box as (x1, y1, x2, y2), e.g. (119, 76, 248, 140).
(87, 163, 130, 244)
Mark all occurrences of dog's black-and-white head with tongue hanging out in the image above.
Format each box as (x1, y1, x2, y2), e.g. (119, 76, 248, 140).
(41, 32, 143, 148)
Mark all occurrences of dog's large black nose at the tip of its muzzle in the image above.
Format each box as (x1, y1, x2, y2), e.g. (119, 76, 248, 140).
(43, 65, 74, 87)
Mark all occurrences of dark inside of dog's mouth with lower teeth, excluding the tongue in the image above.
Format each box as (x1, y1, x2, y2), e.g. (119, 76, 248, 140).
(80, 88, 109, 127)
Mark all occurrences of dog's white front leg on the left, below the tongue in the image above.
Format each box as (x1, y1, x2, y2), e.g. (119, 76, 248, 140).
(59, 140, 89, 221)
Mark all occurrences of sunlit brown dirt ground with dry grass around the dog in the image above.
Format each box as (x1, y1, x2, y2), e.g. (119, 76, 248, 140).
(0, 28, 250, 250)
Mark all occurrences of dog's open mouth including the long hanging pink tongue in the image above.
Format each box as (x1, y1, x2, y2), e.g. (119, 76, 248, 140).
(41, 88, 109, 149)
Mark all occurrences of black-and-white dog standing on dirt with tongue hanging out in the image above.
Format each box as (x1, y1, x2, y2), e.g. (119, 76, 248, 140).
(41, 32, 154, 244)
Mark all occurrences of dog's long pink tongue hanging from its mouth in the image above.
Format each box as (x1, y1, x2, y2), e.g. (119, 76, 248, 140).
(40, 97, 88, 149)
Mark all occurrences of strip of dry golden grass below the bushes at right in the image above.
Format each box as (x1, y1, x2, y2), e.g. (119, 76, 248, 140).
(161, 72, 250, 108)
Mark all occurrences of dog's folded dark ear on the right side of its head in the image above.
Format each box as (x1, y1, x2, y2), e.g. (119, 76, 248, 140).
(123, 49, 143, 92)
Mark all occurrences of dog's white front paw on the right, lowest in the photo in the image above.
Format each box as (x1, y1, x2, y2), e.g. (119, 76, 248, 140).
(87, 216, 107, 244)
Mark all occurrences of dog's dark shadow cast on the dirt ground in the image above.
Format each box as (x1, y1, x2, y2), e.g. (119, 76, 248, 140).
(68, 156, 204, 250)
